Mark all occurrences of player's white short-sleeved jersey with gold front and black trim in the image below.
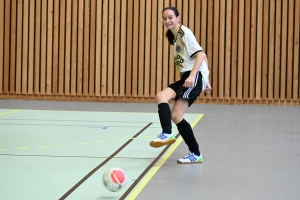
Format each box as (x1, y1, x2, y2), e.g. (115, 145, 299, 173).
(173, 25, 209, 90)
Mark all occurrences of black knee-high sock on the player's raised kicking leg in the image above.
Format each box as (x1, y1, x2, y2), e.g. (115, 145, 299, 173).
(158, 103, 172, 133)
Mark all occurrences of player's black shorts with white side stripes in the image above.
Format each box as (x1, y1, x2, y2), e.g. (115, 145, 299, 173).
(168, 71, 203, 107)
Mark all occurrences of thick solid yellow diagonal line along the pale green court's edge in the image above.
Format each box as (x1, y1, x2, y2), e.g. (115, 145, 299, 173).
(128, 114, 204, 200)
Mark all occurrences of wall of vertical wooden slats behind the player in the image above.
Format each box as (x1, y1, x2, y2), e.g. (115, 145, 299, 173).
(0, 0, 300, 105)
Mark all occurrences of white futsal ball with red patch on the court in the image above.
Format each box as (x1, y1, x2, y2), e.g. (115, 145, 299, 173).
(102, 167, 126, 192)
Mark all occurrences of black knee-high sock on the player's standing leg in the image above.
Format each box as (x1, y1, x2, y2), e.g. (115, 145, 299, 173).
(176, 119, 200, 156)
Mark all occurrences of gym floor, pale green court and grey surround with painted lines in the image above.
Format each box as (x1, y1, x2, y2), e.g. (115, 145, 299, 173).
(0, 100, 300, 200)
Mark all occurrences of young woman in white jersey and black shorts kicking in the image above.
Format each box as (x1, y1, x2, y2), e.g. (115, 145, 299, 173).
(150, 6, 211, 163)
